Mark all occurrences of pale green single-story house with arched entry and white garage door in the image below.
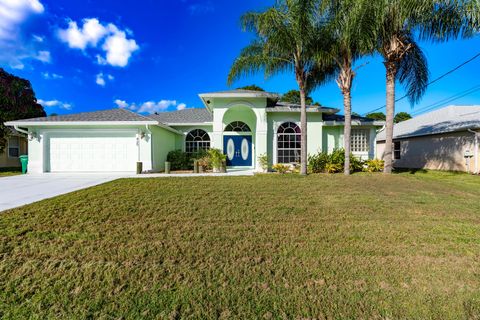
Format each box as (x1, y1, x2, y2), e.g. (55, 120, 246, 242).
(7, 90, 384, 173)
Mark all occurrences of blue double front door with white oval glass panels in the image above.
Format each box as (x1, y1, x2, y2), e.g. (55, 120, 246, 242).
(223, 136, 252, 167)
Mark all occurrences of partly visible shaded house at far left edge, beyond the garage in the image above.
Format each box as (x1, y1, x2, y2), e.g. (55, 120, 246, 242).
(0, 127, 27, 168)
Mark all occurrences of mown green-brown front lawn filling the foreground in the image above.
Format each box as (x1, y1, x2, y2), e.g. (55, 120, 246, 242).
(0, 173, 480, 319)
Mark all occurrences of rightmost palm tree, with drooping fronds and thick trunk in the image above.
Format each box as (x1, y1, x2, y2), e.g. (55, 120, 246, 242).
(370, 0, 480, 174)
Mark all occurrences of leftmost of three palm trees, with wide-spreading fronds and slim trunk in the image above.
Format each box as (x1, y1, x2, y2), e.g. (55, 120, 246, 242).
(228, 0, 334, 175)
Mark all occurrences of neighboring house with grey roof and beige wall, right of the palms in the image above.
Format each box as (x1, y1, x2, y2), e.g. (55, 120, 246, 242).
(377, 106, 480, 173)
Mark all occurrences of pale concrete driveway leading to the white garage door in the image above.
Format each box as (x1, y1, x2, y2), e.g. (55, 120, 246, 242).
(0, 173, 132, 211)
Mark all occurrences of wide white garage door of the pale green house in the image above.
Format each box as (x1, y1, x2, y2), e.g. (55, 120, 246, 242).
(49, 133, 138, 172)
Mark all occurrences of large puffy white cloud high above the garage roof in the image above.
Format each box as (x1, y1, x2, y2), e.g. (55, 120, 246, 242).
(58, 18, 140, 67)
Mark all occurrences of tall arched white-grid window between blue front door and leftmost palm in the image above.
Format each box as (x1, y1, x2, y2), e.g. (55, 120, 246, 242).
(277, 122, 302, 163)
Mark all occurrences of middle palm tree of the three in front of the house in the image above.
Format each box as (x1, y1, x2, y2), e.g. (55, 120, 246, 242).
(318, 0, 375, 175)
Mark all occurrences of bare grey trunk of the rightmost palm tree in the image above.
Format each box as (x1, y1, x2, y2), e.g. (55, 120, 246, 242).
(383, 61, 397, 174)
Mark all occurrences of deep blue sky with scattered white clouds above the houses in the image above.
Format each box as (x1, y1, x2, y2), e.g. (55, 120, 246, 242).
(0, 0, 480, 115)
